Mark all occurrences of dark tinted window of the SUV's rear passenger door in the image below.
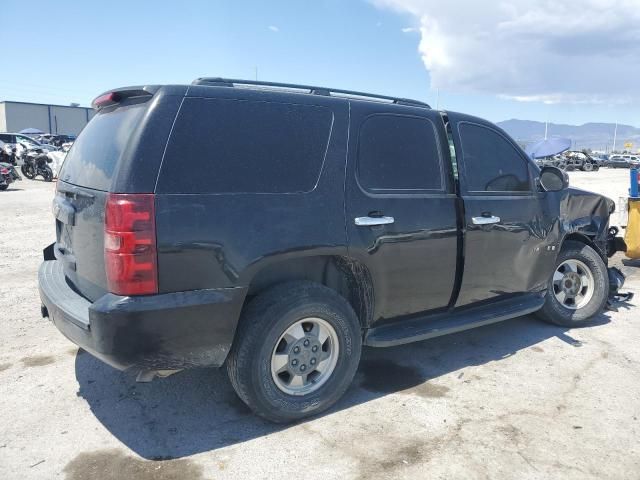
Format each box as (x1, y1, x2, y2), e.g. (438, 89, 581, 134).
(358, 115, 442, 191)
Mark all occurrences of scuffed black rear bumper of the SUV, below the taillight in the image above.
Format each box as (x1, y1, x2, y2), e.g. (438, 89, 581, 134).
(38, 260, 246, 370)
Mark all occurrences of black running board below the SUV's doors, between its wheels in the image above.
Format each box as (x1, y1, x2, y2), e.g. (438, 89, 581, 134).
(364, 294, 544, 347)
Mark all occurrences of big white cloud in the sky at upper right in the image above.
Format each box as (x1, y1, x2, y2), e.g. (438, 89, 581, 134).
(371, 0, 640, 104)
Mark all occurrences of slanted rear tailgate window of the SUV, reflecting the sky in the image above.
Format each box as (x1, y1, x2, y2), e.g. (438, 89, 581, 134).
(60, 104, 146, 191)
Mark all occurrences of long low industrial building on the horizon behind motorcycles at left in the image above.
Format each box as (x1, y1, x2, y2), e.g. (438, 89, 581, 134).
(0, 101, 94, 135)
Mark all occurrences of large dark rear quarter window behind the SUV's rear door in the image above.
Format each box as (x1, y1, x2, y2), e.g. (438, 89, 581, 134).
(157, 98, 333, 193)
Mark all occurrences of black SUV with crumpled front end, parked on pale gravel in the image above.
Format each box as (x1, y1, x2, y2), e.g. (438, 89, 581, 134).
(39, 78, 615, 421)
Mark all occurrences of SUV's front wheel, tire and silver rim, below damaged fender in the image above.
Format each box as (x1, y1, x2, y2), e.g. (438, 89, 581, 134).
(538, 241, 609, 327)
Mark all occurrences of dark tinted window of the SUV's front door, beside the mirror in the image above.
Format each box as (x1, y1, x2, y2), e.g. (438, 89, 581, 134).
(459, 123, 530, 192)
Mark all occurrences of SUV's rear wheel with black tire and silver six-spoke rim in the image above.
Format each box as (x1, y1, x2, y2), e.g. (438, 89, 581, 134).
(227, 282, 362, 423)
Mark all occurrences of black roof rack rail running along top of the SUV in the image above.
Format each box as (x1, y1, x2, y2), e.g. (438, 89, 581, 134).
(191, 77, 431, 108)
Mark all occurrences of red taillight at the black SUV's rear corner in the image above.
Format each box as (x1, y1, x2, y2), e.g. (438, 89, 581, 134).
(104, 193, 158, 295)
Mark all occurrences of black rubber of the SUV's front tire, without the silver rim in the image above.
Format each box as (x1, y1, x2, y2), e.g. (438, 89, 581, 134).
(537, 241, 609, 327)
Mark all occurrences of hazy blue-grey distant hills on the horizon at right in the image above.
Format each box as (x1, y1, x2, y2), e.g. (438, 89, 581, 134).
(498, 119, 640, 151)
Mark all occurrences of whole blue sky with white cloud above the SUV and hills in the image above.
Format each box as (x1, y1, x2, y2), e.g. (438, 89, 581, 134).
(0, 0, 640, 126)
